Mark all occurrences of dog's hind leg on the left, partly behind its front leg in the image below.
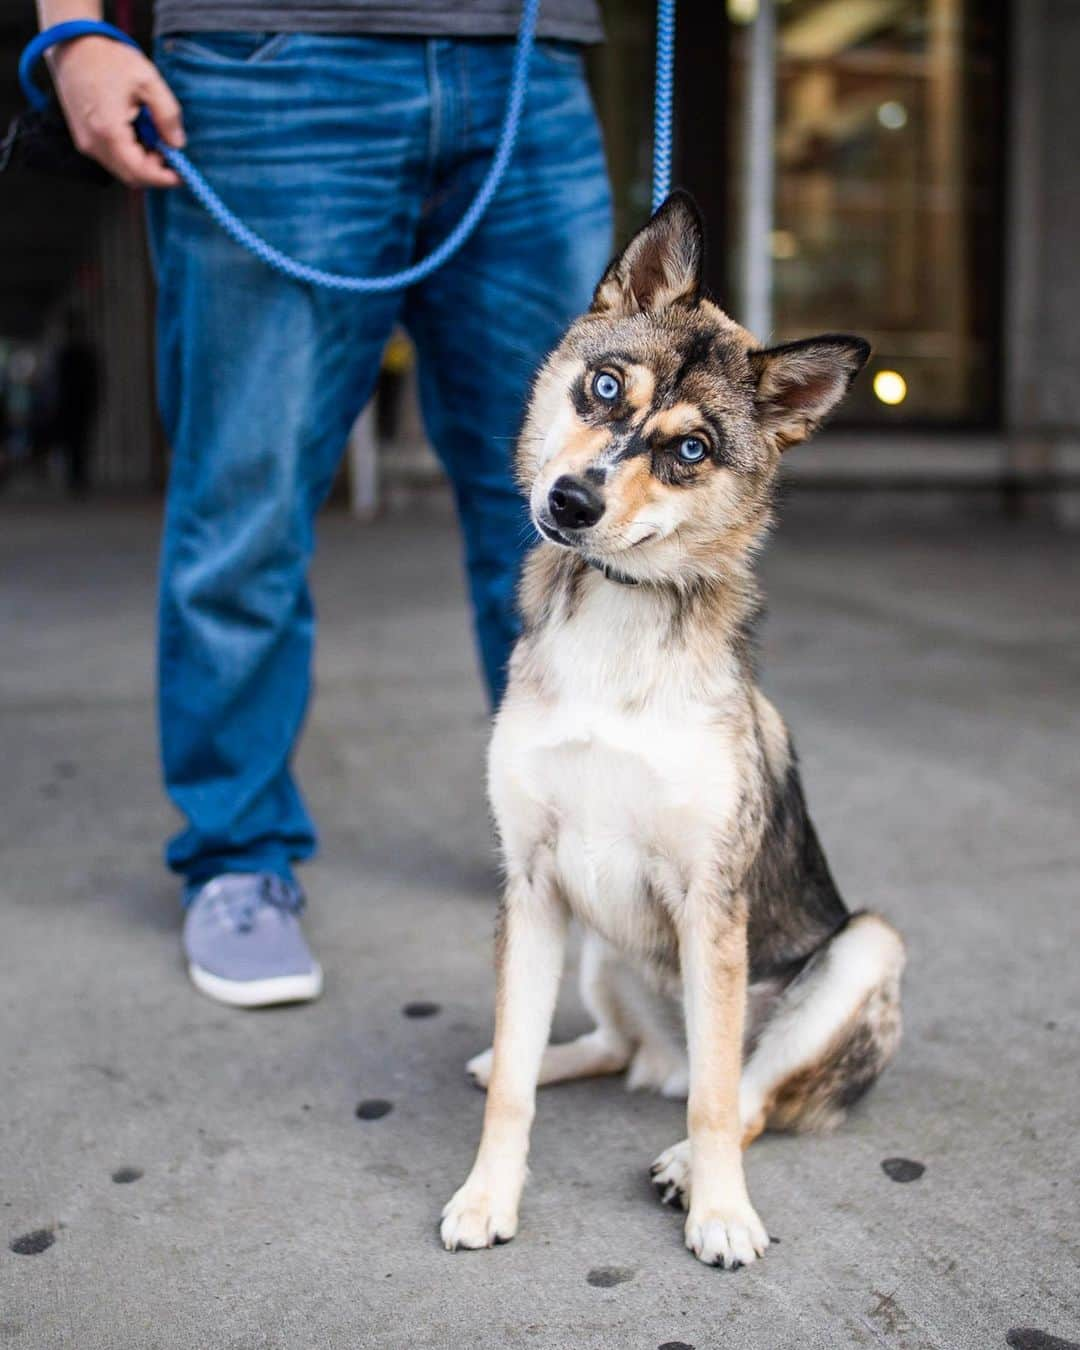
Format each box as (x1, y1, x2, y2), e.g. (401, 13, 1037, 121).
(466, 933, 633, 1088)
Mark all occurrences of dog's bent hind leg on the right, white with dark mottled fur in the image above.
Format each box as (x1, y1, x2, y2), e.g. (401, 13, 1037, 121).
(738, 914, 905, 1146)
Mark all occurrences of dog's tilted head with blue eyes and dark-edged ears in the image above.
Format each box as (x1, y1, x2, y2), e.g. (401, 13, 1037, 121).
(517, 193, 869, 581)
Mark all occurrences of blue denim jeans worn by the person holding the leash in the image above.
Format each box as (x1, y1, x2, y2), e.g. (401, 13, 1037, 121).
(150, 34, 610, 887)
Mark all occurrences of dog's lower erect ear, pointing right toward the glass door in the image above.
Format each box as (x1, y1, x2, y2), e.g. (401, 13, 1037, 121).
(749, 333, 869, 450)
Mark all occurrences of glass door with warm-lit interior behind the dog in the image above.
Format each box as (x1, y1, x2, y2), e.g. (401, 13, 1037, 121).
(726, 0, 1003, 425)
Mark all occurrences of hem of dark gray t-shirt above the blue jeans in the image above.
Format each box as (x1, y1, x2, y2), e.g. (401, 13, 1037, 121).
(154, 0, 603, 42)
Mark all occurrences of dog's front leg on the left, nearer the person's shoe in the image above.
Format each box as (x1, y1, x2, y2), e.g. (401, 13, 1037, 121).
(441, 873, 567, 1251)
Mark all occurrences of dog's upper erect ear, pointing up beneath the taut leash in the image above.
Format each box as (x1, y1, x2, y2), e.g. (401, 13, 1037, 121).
(591, 192, 705, 317)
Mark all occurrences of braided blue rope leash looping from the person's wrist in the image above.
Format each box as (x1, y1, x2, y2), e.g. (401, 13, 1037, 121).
(19, 0, 675, 294)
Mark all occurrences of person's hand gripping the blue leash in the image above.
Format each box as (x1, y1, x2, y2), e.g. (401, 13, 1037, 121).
(49, 36, 184, 188)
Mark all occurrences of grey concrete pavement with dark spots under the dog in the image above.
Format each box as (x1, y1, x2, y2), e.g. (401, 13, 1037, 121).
(0, 502, 1080, 1350)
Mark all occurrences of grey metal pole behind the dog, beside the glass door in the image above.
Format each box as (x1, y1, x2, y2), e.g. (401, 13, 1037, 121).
(743, 0, 776, 343)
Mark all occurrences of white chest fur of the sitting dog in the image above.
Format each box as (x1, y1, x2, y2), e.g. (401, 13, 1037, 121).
(490, 579, 737, 956)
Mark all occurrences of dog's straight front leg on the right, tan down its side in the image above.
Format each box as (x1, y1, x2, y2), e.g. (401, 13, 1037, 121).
(679, 887, 768, 1269)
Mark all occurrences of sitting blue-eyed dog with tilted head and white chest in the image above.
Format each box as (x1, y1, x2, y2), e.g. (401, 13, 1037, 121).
(441, 193, 905, 1269)
